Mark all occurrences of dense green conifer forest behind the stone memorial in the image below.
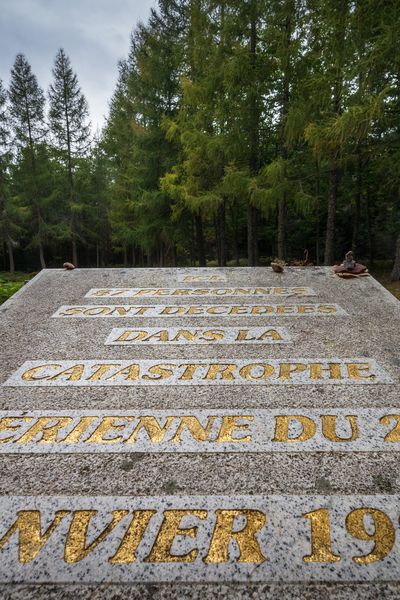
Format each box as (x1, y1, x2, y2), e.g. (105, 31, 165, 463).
(0, 0, 400, 292)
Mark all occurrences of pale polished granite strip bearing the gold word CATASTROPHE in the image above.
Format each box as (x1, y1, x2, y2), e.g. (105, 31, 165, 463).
(4, 358, 392, 386)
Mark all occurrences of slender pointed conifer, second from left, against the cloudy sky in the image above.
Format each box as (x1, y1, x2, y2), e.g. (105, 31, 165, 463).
(49, 48, 90, 265)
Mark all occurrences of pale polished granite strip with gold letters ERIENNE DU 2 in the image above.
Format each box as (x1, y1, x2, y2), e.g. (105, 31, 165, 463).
(0, 408, 400, 453)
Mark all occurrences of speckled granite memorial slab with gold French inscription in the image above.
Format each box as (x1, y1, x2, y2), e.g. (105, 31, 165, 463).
(0, 267, 400, 600)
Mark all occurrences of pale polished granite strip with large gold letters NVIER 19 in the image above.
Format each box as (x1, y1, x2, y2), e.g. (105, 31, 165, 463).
(0, 496, 400, 582)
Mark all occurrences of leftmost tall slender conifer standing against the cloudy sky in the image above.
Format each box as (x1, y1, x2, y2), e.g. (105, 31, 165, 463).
(9, 54, 46, 269)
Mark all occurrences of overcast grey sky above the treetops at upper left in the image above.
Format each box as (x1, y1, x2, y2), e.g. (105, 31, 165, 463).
(0, 0, 155, 129)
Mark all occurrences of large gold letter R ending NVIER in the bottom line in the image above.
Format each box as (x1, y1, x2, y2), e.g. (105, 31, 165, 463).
(204, 509, 267, 564)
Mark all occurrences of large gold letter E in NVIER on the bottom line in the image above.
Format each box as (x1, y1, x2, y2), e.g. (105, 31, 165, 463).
(144, 510, 208, 563)
